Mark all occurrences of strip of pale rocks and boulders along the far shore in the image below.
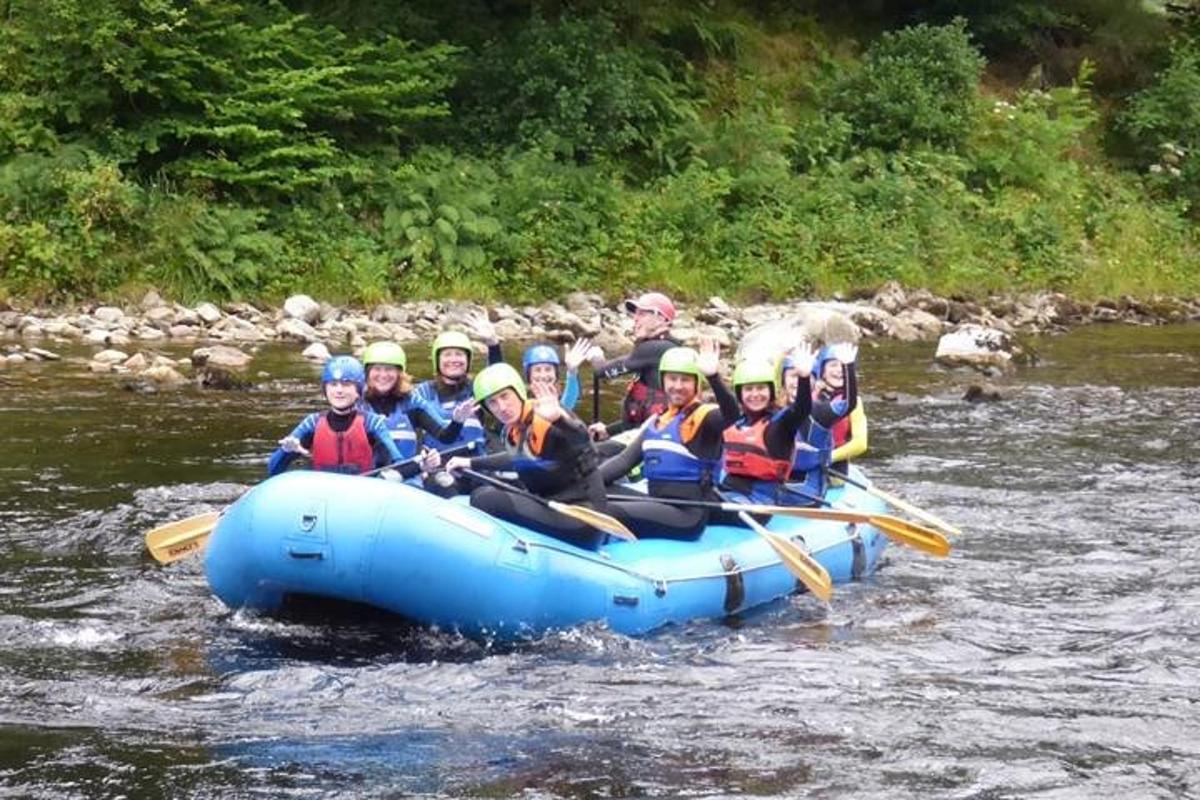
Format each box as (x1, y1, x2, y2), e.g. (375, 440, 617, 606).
(0, 283, 1200, 384)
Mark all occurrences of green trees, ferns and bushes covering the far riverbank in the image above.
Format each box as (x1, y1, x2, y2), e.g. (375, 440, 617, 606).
(0, 0, 1200, 302)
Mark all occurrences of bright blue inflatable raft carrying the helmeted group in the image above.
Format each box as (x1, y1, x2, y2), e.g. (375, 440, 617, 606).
(205, 471, 887, 640)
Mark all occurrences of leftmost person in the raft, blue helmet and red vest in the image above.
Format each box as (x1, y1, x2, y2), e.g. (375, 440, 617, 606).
(266, 355, 402, 476)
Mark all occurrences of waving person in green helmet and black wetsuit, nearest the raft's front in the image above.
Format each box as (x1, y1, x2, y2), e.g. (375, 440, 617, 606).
(446, 363, 607, 549)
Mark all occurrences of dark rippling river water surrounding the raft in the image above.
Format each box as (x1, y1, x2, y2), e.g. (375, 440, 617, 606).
(0, 326, 1200, 799)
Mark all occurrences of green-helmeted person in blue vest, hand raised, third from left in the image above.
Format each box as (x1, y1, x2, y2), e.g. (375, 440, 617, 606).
(413, 314, 504, 450)
